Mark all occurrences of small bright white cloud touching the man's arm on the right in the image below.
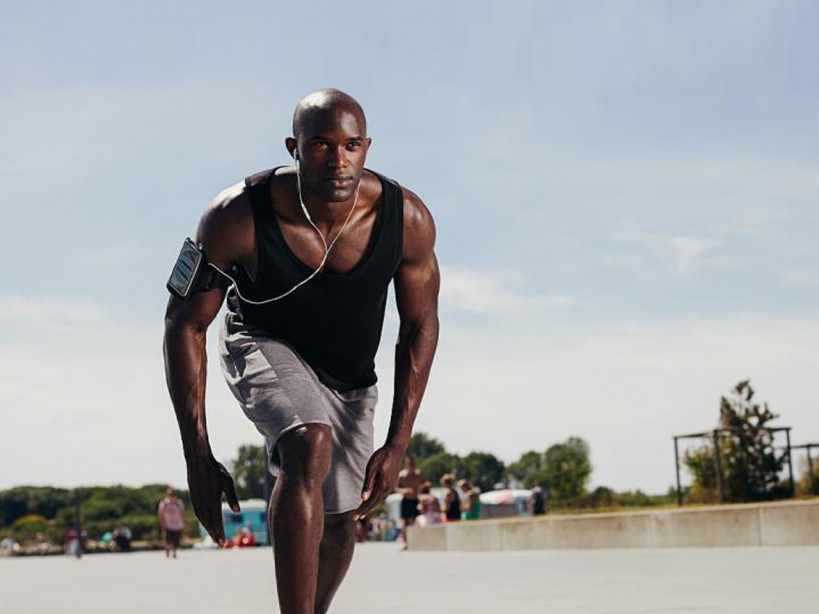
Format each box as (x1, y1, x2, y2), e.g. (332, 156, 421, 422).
(441, 267, 577, 315)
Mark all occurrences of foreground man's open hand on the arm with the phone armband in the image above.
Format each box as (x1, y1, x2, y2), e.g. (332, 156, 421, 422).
(188, 456, 241, 546)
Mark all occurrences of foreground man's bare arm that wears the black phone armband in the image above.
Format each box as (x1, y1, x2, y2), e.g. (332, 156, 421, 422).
(163, 187, 253, 543)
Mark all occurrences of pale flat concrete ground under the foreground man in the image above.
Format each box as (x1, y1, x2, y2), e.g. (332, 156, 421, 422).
(0, 543, 819, 614)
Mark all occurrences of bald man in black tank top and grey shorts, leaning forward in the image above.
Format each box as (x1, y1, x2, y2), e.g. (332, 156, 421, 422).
(164, 90, 439, 614)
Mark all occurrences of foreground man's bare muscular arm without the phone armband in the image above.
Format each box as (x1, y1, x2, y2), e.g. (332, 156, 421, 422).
(356, 190, 441, 517)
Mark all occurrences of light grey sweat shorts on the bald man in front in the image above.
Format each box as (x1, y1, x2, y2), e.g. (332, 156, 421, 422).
(219, 312, 378, 514)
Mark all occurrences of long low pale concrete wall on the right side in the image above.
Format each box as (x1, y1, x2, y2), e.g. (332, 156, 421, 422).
(407, 500, 819, 551)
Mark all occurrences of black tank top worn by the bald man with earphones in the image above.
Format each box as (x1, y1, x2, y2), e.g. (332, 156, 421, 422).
(228, 169, 404, 392)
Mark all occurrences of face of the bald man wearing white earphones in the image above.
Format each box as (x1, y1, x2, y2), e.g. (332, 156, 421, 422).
(294, 107, 370, 202)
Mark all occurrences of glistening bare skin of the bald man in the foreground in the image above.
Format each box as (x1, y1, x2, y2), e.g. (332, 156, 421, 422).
(164, 90, 440, 614)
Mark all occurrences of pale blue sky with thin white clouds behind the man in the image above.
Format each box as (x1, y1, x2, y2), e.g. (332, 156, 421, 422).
(0, 0, 819, 493)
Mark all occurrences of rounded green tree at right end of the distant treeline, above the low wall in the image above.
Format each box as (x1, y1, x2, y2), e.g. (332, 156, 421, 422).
(542, 437, 592, 505)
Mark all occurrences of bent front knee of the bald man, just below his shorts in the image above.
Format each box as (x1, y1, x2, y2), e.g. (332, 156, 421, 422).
(276, 424, 333, 484)
